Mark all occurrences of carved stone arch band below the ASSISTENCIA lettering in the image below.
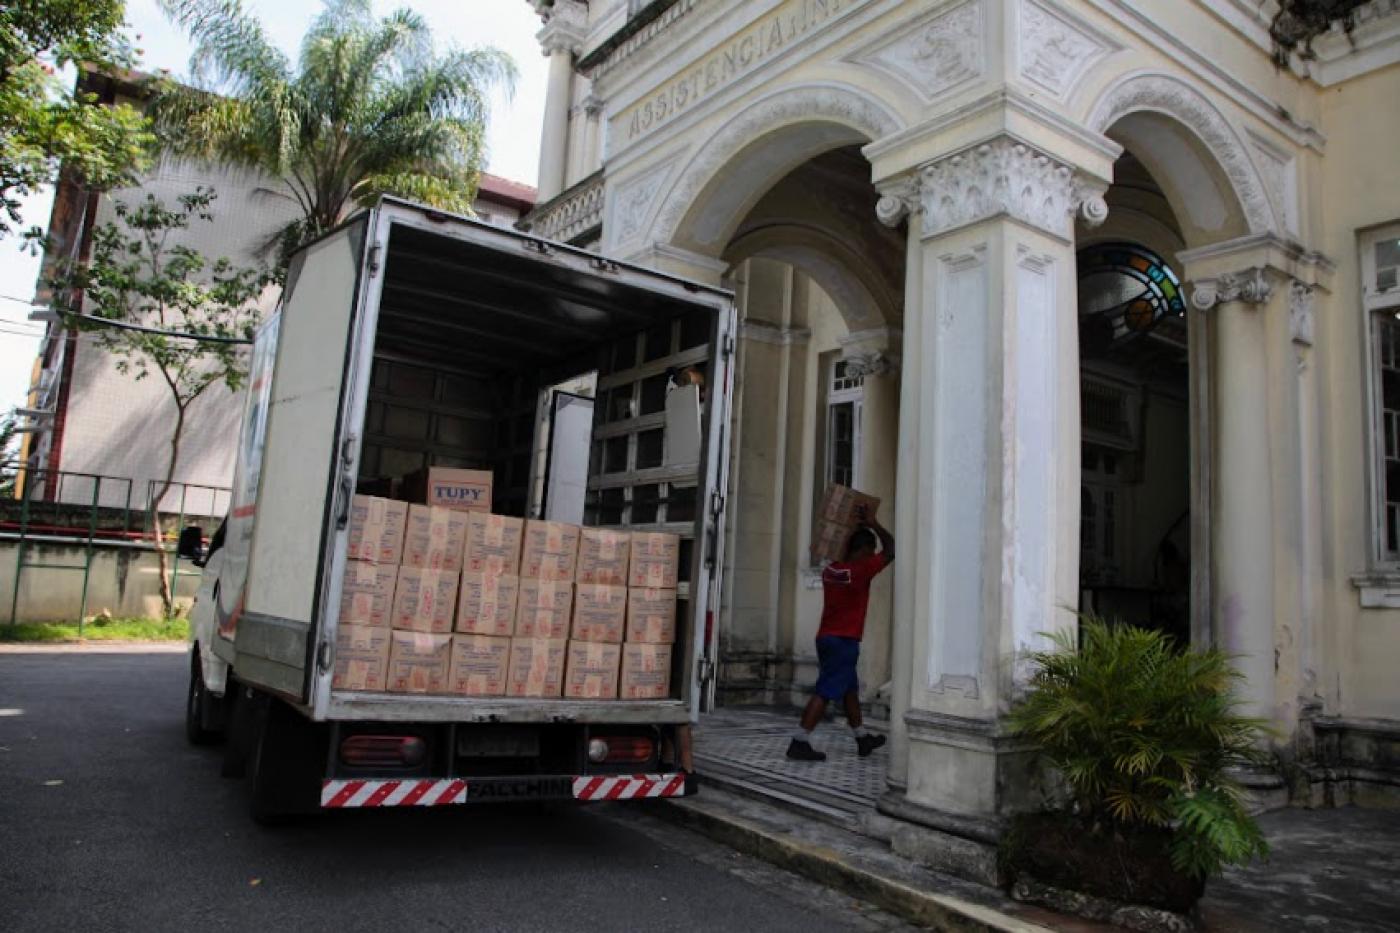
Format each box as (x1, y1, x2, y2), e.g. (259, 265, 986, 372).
(647, 83, 903, 255)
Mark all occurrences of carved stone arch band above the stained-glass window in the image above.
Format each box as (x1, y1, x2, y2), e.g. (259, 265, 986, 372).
(1085, 71, 1277, 239)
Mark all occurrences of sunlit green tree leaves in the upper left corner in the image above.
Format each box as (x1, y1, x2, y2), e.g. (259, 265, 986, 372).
(0, 0, 155, 238)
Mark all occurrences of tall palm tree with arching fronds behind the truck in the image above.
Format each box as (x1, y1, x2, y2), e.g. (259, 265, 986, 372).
(155, 0, 515, 267)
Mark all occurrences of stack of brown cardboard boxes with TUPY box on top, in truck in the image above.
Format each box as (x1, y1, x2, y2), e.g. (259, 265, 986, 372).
(335, 469, 680, 699)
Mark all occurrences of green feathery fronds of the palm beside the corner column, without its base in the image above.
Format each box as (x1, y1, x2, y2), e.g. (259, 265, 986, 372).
(1012, 618, 1267, 877)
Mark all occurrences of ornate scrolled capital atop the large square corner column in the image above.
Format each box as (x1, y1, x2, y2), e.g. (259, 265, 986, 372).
(896, 134, 1109, 241)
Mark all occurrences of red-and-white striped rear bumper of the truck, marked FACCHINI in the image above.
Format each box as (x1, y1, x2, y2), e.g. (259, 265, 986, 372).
(321, 772, 694, 810)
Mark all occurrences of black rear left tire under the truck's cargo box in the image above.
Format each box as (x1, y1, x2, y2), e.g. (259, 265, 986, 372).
(248, 699, 326, 825)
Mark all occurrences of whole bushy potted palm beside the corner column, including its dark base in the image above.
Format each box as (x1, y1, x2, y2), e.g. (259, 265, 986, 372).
(1002, 618, 1268, 929)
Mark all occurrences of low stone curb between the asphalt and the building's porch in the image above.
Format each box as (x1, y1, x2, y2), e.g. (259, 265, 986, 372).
(654, 787, 1051, 933)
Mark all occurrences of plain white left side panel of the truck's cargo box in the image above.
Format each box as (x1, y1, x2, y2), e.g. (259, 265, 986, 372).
(249, 224, 363, 633)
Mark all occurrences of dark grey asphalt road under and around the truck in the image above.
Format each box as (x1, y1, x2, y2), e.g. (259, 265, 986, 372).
(0, 653, 906, 933)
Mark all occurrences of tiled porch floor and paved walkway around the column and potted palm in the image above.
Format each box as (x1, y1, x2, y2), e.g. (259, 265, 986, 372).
(686, 707, 1400, 933)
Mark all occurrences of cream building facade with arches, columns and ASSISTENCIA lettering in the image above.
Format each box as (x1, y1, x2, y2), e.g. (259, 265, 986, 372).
(522, 0, 1400, 876)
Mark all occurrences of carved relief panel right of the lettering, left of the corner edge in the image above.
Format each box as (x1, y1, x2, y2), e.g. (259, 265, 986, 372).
(853, 0, 986, 101)
